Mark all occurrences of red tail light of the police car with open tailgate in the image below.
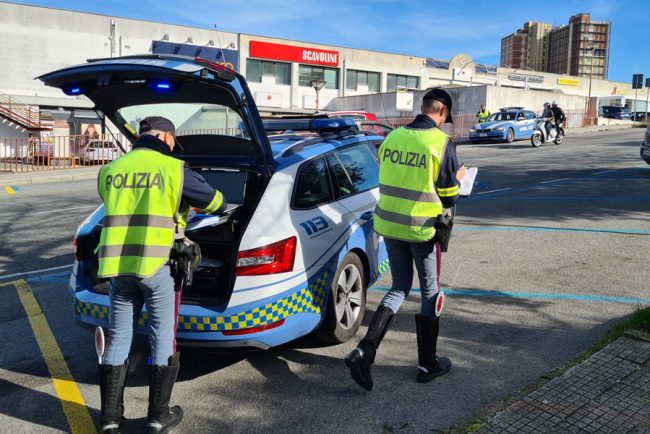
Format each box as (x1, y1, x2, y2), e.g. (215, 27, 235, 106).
(236, 237, 297, 276)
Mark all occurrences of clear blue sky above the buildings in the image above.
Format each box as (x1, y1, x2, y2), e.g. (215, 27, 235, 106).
(6, 0, 650, 82)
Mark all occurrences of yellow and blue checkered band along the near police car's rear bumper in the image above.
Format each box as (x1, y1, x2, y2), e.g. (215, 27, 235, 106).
(74, 272, 330, 331)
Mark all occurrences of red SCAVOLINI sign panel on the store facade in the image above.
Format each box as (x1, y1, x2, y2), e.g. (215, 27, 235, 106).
(250, 41, 339, 66)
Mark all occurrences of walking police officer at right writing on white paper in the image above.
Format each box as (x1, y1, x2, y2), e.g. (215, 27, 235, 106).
(345, 89, 466, 390)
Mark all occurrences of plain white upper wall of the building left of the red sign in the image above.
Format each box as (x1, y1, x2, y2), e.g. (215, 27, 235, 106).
(0, 2, 237, 107)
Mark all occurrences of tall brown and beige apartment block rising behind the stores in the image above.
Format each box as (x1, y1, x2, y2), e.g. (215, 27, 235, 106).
(501, 13, 611, 79)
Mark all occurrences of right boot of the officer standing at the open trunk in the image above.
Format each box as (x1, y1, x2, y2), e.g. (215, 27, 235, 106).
(147, 353, 183, 434)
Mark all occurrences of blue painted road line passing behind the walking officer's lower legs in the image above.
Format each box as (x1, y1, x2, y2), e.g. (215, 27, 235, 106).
(368, 286, 650, 305)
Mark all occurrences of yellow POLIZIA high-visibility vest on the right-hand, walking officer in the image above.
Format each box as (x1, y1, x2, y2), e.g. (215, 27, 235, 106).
(374, 127, 448, 242)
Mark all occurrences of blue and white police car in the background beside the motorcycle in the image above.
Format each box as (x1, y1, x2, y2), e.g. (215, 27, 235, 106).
(469, 107, 537, 143)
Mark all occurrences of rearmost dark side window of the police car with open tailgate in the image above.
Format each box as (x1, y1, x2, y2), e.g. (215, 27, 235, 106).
(293, 158, 333, 209)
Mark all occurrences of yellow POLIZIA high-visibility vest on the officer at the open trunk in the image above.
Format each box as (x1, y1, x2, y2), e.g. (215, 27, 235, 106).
(97, 149, 183, 277)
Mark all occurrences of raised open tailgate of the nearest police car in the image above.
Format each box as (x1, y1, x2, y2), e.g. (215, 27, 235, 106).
(38, 54, 274, 175)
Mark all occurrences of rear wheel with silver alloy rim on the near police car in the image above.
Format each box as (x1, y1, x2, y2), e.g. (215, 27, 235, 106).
(316, 252, 367, 344)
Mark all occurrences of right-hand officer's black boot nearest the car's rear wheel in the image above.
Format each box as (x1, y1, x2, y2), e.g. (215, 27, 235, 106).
(345, 305, 395, 390)
